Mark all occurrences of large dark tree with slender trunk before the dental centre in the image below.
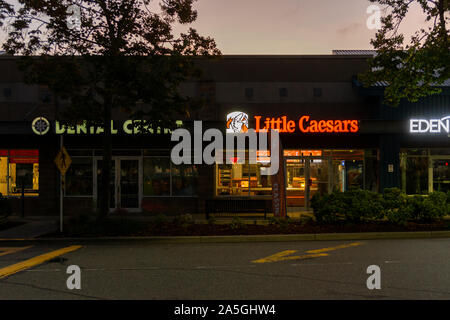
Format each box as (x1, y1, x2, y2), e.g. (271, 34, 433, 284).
(0, 0, 220, 217)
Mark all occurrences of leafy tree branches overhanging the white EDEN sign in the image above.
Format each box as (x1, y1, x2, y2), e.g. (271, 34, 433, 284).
(359, 0, 450, 106)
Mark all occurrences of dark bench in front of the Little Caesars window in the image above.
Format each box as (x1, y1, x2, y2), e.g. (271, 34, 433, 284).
(205, 197, 272, 219)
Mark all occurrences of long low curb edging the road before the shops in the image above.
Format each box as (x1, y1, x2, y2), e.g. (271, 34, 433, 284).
(0, 231, 450, 244)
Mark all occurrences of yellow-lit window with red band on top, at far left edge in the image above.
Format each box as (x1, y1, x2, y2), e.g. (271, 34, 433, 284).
(0, 150, 39, 196)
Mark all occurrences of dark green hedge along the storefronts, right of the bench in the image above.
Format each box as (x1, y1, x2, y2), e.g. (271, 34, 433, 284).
(311, 188, 450, 224)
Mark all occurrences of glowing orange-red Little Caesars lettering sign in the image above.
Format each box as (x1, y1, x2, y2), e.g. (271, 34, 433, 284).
(255, 116, 359, 133)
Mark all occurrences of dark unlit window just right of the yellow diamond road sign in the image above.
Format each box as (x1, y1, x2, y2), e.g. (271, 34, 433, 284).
(66, 157, 93, 196)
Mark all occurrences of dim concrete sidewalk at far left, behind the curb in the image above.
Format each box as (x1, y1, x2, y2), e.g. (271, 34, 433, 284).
(0, 217, 58, 239)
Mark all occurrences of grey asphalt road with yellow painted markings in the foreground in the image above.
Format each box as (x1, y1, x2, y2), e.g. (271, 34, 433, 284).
(0, 238, 450, 300)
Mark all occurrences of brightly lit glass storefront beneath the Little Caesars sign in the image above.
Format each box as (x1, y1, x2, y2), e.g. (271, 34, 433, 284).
(216, 149, 378, 199)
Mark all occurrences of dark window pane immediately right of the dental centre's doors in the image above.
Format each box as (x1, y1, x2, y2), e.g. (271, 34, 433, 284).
(143, 157, 170, 196)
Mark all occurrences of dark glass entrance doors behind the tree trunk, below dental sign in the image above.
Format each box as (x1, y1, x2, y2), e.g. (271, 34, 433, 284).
(94, 157, 142, 212)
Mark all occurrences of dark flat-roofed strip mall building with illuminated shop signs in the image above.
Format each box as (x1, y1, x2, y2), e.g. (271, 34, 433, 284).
(0, 51, 450, 215)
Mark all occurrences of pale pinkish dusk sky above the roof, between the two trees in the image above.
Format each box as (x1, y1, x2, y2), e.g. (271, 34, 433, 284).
(0, 0, 424, 54)
